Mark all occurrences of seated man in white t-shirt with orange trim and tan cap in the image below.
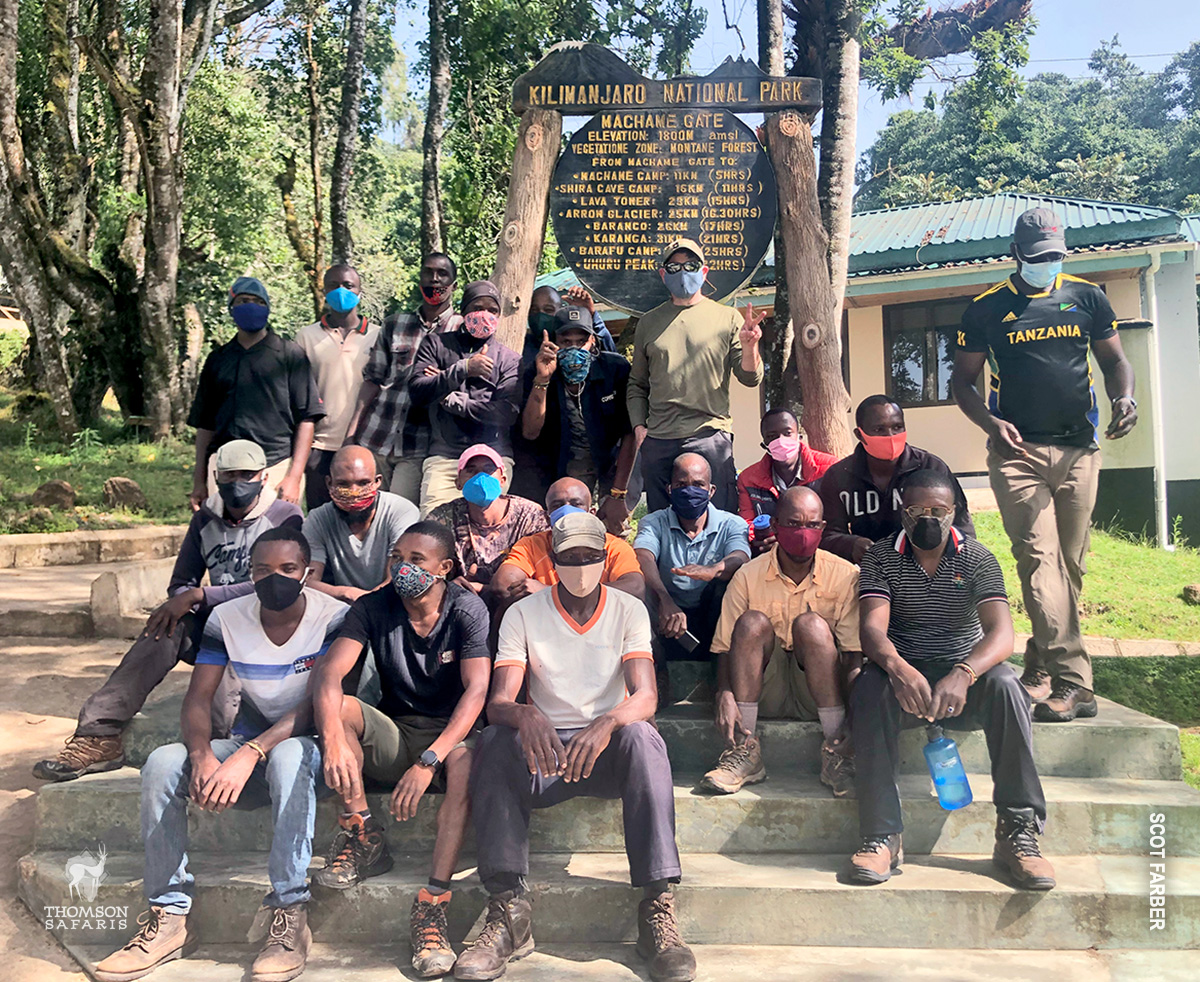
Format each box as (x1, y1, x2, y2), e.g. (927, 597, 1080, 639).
(455, 511, 696, 982)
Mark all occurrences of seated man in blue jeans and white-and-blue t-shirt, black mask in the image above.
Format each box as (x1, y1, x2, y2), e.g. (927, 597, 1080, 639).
(95, 526, 349, 982)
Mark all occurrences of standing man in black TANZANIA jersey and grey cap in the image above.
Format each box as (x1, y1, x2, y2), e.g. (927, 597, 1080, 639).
(952, 208, 1138, 723)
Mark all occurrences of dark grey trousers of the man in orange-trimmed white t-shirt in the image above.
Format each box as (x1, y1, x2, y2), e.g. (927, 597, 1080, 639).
(470, 723, 680, 896)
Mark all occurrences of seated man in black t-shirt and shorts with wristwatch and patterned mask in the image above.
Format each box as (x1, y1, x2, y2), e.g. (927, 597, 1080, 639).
(313, 521, 492, 978)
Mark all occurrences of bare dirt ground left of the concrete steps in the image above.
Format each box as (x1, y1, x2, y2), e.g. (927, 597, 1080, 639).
(0, 637, 187, 982)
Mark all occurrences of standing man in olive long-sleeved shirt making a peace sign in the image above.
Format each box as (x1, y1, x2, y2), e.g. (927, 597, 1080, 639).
(629, 239, 767, 511)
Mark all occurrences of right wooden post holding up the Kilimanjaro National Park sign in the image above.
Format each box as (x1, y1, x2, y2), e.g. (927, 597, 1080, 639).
(766, 110, 853, 456)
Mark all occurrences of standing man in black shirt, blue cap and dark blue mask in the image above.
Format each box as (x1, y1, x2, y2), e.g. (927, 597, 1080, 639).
(187, 276, 325, 511)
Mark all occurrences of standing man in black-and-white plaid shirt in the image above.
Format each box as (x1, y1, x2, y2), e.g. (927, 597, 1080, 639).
(347, 252, 462, 504)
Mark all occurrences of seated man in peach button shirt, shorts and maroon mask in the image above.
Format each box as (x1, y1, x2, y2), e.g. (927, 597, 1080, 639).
(702, 486, 862, 798)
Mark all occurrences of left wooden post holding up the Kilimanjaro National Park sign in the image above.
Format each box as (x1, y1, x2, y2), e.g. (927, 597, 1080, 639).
(492, 109, 563, 352)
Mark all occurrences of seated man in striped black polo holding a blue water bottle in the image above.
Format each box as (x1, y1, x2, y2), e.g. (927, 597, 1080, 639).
(848, 471, 1055, 890)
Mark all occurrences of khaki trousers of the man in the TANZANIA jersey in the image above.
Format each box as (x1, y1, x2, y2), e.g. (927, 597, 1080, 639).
(988, 443, 1100, 689)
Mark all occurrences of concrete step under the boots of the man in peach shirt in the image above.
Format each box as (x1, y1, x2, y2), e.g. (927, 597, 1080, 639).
(37, 768, 1200, 856)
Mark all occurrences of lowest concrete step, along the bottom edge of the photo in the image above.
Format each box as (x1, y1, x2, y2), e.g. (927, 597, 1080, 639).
(56, 942, 1196, 982)
